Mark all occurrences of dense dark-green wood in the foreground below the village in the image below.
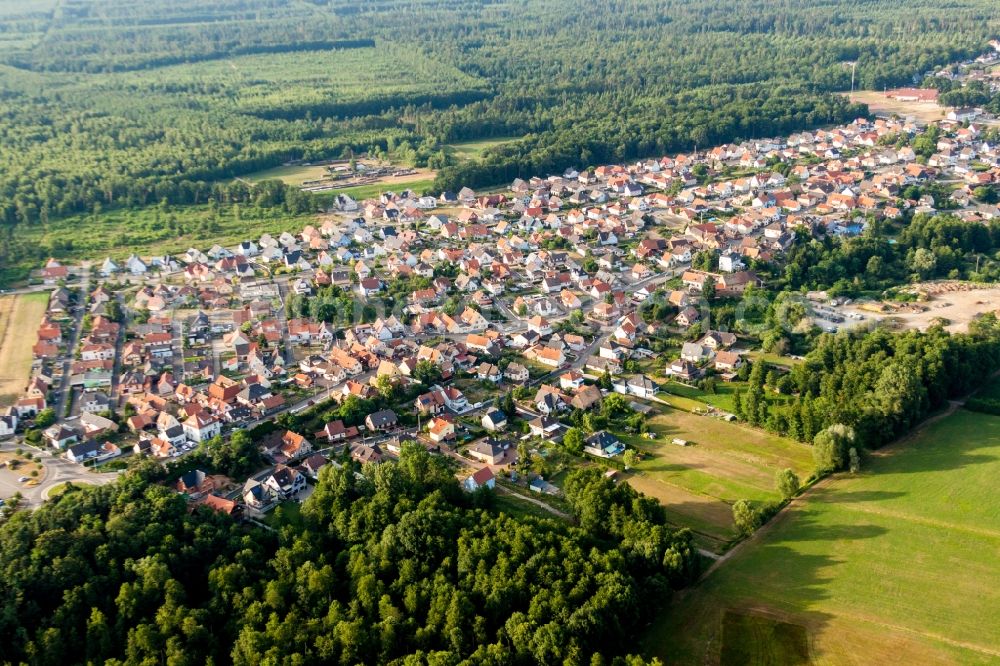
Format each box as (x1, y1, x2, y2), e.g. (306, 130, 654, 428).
(0, 446, 696, 665)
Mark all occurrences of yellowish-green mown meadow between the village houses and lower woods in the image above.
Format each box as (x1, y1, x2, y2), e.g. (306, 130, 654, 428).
(626, 410, 812, 550)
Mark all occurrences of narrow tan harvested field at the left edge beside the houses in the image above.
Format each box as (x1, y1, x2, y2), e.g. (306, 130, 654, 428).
(0, 293, 49, 407)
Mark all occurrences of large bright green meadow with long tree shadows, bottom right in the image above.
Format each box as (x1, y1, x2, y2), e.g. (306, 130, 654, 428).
(647, 410, 1000, 665)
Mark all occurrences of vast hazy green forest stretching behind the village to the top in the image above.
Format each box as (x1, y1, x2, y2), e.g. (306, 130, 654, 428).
(0, 0, 1000, 238)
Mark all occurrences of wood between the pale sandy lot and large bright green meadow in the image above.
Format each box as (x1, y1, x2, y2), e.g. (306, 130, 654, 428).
(737, 313, 1000, 448)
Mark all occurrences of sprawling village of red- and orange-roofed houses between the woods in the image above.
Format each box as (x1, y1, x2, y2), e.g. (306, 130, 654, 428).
(0, 81, 1000, 517)
